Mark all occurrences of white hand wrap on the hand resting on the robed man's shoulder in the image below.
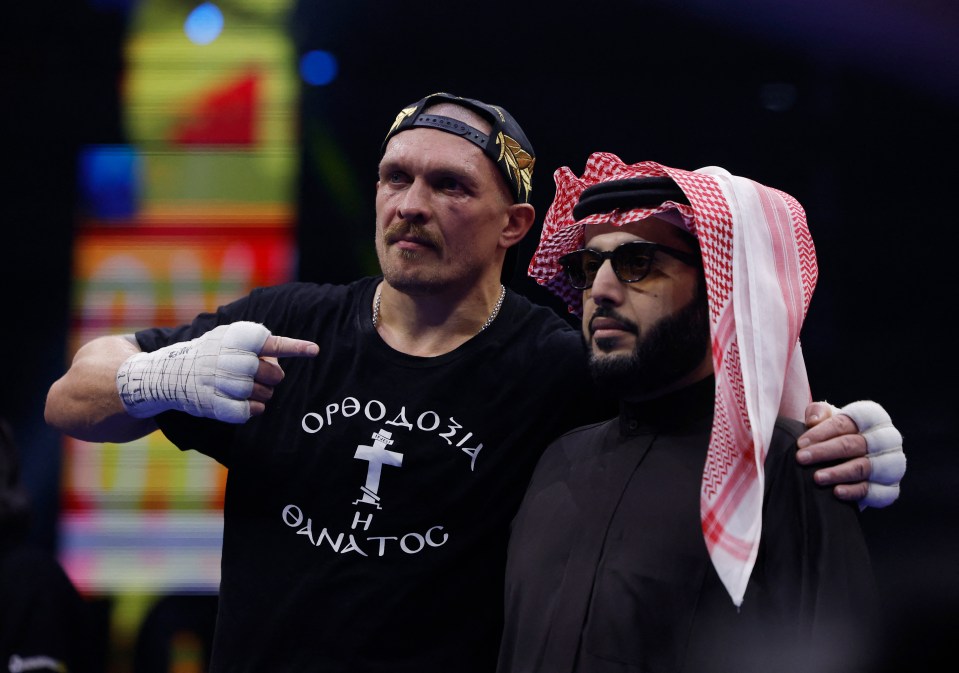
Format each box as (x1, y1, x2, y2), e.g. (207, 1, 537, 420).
(833, 400, 906, 507)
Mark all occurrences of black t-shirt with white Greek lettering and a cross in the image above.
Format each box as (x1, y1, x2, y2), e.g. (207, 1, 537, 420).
(137, 278, 614, 673)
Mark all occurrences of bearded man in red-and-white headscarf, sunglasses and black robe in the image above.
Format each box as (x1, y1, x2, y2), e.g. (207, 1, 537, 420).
(500, 153, 901, 673)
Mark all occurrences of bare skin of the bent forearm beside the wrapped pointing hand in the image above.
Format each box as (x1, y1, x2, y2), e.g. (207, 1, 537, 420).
(44, 336, 156, 442)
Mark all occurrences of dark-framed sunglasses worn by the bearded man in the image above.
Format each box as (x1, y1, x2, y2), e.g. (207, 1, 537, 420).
(559, 241, 699, 290)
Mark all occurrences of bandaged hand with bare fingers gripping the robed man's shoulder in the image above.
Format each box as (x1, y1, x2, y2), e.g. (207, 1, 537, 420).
(796, 401, 906, 508)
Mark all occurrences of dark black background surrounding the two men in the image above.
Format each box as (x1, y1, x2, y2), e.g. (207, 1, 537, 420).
(0, 0, 959, 671)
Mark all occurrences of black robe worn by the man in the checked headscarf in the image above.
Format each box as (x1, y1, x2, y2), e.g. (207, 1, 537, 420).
(499, 377, 876, 673)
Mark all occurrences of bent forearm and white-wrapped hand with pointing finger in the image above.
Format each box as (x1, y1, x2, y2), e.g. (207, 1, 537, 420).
(45, 321, 319, 442)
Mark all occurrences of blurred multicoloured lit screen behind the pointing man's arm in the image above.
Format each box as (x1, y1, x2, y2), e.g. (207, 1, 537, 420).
(58, 0, 298, 598)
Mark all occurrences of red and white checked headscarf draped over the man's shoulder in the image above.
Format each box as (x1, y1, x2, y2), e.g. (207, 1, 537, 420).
(529, 152, 818, 606)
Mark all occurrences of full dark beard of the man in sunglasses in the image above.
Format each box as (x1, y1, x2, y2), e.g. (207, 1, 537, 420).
(589, 292, 709, 398)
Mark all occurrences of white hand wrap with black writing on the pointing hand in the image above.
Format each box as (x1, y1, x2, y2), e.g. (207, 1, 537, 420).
(117, 322, 270, 423)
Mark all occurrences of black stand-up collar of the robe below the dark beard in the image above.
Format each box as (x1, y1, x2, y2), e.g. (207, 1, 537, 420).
(619, 375, 716, 437)
